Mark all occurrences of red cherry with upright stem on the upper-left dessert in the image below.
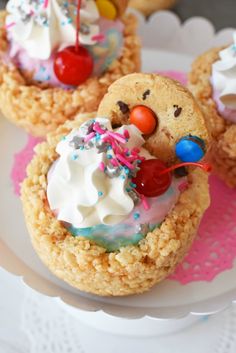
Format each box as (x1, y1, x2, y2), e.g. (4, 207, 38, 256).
(54, 0, 94, 86)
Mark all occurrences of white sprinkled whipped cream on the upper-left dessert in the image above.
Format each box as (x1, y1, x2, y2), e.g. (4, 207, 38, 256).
(6, 0, 99, 60)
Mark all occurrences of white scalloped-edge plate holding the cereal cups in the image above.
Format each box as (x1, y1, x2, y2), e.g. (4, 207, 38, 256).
(0, 12, 236, 318)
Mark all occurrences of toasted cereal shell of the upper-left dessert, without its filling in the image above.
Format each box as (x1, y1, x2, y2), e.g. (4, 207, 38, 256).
(0, 11, 140, 136)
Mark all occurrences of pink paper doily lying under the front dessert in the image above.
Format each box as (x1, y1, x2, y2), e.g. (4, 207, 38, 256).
(11, 71, 236, 284)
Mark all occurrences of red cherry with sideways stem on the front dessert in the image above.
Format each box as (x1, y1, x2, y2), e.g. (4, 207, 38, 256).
(132, 159, 211, 197)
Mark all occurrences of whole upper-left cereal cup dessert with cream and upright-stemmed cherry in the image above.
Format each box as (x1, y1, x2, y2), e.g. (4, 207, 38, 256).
(0, 0, 140, 136)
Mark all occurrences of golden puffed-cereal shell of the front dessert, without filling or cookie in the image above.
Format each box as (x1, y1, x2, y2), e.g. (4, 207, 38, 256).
(21, 116, 209, 296)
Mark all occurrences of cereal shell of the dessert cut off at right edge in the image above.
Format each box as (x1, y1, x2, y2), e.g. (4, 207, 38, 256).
(189, 48, 236, 188)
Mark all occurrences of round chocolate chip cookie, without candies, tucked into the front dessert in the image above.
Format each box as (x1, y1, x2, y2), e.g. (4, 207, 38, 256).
(98, 73, 208, 164)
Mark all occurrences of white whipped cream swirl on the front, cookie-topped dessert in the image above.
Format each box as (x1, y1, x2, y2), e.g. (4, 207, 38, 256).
(47, 118, 151, 228)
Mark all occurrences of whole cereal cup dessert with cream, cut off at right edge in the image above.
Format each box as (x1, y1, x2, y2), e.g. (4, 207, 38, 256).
(189, 33, 236, 187)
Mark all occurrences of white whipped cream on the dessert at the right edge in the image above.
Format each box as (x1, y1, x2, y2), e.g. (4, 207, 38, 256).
(212, 32, 236, 110)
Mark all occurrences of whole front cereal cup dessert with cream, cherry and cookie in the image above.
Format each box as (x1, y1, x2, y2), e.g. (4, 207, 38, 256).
(21, 74, 209, 296)
